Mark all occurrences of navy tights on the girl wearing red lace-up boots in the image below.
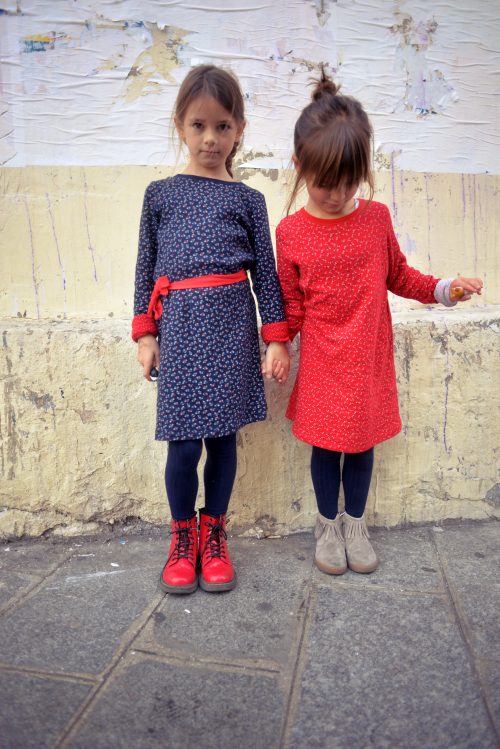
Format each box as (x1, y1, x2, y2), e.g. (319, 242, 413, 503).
(165, 434, 236, 520)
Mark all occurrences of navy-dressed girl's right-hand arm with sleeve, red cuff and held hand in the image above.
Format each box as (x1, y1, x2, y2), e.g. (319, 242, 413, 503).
(250, 193, 290, 382)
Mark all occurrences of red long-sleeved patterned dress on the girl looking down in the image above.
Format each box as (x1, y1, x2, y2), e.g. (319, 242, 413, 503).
(276, 200, 439, 453)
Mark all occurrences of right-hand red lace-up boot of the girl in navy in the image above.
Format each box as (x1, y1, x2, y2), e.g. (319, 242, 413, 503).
(200, 510, 236, 593)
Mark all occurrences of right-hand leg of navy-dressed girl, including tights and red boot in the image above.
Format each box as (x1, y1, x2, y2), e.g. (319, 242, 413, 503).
(200, 434, 236, 593)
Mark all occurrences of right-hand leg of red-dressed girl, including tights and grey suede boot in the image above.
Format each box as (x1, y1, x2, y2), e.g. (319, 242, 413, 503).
(342, 448, 378, 573)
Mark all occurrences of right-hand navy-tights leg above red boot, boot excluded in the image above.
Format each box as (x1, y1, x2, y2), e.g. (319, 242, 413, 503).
(203, 434, 236, 517)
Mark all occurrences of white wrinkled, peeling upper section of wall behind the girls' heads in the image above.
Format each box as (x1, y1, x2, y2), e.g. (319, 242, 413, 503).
(0, 0, 500, 173)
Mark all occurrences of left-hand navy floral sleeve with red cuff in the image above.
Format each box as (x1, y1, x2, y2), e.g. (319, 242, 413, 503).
(132, 183, 159, 341)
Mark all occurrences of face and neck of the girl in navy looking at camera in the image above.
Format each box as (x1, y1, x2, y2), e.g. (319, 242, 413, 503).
(175, 96, 245, 180)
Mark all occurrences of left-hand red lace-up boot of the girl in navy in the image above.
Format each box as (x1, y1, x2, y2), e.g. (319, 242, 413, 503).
(160, 515, 198, 593)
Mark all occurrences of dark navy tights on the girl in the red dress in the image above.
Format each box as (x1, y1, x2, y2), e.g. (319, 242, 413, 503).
(311, 447, 373, 520)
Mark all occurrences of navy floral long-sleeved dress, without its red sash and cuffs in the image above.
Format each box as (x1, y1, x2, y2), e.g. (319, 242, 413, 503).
(134, 174, 285, 440)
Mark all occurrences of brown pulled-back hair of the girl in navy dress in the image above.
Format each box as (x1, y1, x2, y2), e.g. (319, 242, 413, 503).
(174, 65, 245, 177)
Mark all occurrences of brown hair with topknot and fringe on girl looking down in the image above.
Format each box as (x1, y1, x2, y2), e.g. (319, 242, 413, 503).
(287, 66, 374, 213)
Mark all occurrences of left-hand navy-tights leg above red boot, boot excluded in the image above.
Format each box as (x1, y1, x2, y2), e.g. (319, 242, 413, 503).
(165, 440, 203, 520)
